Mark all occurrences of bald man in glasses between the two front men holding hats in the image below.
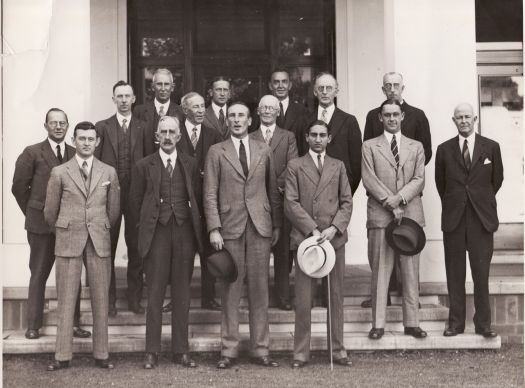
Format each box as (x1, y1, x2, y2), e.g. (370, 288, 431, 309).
(250, 95, 298, 310)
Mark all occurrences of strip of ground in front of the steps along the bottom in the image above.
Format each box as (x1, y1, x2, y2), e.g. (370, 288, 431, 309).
(3, 345, 524, 388)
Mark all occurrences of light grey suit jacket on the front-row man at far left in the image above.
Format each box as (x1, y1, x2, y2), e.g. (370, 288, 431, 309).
(44, 158, 120, 257)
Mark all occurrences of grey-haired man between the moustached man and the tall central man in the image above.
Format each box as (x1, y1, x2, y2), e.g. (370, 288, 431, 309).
(177, 92, 222, 310)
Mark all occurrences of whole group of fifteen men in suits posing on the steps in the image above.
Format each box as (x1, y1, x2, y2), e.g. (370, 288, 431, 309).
(13, 65, 503, 370)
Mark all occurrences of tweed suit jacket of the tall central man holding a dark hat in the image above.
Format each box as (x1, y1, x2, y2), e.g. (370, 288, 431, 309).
(204, 137, 282, 240)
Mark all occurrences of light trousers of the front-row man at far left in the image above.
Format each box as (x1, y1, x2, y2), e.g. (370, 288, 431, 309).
(55, 238, 111, 361)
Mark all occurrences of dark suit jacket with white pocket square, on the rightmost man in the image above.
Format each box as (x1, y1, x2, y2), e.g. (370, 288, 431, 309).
(436, 134, 503, 232)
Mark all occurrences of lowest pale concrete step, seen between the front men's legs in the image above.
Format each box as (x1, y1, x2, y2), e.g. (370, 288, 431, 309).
(3, 324, 501, 354)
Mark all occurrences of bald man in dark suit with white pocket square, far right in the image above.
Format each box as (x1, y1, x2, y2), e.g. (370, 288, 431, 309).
(436, 103, 503, 338)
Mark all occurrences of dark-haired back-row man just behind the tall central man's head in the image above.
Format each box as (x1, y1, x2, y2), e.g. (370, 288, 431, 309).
(204, 76, 230, 140)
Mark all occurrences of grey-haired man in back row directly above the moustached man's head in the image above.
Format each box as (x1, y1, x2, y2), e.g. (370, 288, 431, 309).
(133, 69, 184, 149)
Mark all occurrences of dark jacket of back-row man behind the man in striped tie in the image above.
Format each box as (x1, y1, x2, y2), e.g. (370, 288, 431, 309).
(363, 101, 432, 165)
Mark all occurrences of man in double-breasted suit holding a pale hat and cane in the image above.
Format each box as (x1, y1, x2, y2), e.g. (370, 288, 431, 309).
(284, 120, 352, 369)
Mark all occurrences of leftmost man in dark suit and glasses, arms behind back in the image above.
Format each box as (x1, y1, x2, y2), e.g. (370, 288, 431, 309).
(11, 108, 91, 339)
